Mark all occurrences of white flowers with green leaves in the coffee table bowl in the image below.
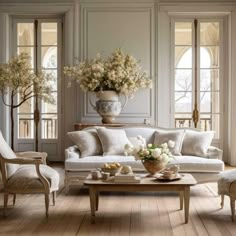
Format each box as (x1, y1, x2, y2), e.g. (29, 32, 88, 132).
(124, 136, 175, 163)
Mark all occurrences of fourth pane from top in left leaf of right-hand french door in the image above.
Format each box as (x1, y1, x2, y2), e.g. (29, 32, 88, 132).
(175, 92, 192, 112)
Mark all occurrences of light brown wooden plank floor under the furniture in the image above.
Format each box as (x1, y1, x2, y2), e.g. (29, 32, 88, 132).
(0, 167, 236, 236)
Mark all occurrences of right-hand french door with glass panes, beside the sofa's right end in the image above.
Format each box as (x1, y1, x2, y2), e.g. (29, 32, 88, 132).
(172, 19, 223, 146)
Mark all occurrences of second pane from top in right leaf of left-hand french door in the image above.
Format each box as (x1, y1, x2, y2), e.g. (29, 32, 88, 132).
(41, 47, 57, 68)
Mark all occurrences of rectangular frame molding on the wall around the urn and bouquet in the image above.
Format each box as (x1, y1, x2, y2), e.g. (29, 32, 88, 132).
(78, 2, 157, 123)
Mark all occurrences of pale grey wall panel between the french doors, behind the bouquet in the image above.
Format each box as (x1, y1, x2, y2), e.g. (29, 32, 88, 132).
(80, 3, 155, 122)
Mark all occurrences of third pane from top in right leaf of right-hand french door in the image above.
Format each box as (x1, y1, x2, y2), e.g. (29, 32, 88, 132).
(200, 69, 220, 92)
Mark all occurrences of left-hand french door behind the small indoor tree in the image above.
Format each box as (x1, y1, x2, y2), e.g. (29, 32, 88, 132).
(13, 19, 62, 160)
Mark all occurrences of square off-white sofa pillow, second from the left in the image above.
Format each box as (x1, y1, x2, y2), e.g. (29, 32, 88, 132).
(97, 128, 130, 156)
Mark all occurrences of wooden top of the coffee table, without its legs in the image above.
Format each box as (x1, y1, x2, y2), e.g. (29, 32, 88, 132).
(84, 174, 197, 186)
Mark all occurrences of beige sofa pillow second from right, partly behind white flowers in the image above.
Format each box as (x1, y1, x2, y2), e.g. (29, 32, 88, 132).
(154, 130, 185, 156)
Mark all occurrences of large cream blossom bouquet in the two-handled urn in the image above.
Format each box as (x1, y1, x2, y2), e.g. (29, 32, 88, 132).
(64, 49, 152, 97)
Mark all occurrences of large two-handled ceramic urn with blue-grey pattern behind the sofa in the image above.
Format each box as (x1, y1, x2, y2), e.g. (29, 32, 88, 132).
(89, 90, 128, 124)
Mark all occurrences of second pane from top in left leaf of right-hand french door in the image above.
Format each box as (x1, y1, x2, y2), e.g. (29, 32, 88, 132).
(175, 46, 192, 68)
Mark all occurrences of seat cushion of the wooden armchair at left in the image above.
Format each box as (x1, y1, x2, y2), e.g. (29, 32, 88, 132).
(6, 165, 59, 192)
